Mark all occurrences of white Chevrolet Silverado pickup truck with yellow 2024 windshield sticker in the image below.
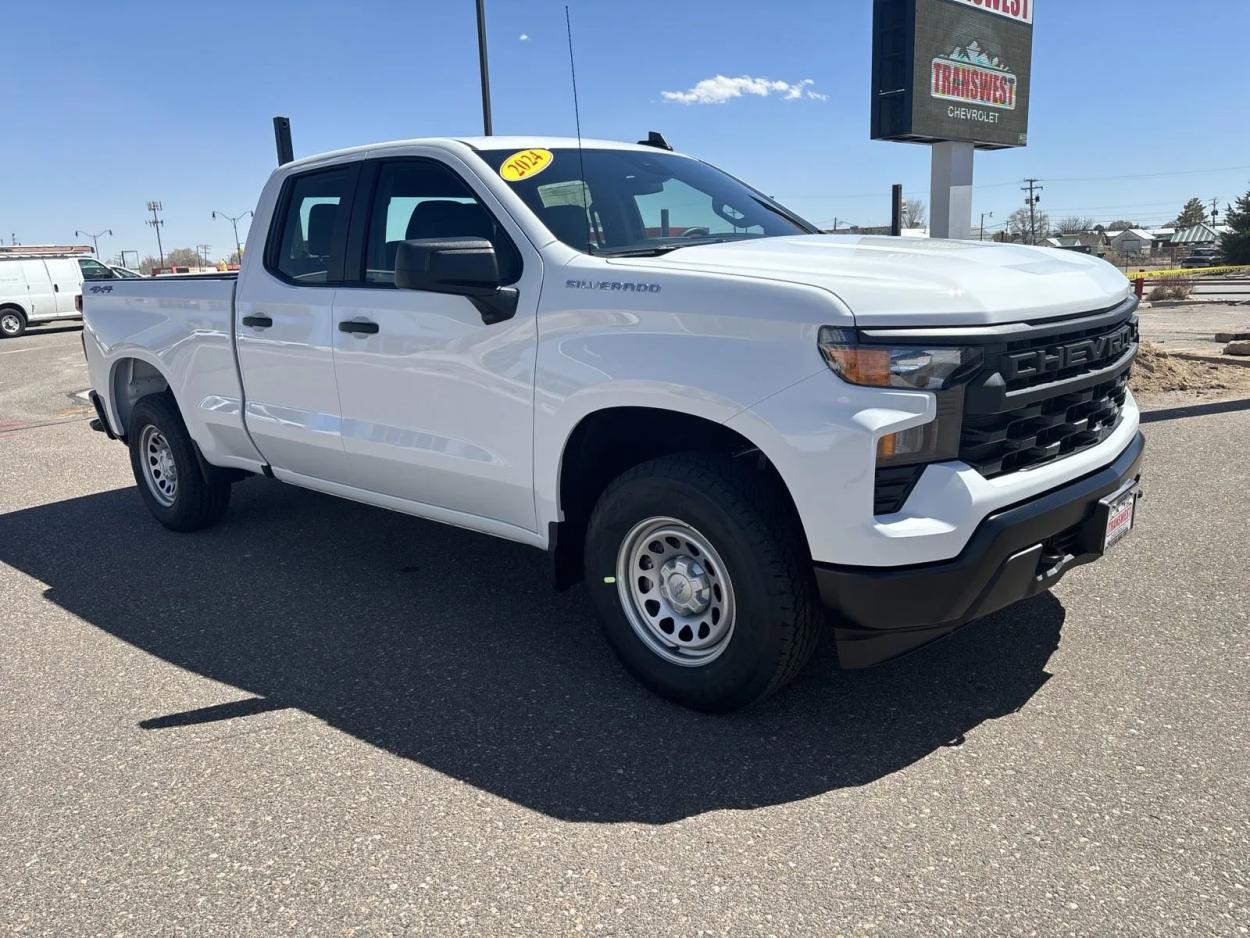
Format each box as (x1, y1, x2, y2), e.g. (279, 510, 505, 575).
(84, 136, 1143, 710)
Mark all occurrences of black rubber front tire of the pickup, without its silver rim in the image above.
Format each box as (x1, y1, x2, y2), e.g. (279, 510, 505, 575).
(585, 453, 825, 713)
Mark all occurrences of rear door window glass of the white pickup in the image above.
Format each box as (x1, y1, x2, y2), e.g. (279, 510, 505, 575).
(269, 166, 353, 284)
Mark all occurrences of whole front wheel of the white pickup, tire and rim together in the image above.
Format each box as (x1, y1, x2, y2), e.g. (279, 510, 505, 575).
(585, 454, 824, 712)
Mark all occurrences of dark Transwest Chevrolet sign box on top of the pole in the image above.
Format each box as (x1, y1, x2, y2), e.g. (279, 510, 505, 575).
(873, 0, 1034, 149)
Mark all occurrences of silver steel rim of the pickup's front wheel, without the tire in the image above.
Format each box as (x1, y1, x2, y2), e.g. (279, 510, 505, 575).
(616, 518, 736, 668)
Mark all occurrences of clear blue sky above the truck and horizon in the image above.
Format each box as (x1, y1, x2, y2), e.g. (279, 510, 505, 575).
(0, 0, 1250, 256)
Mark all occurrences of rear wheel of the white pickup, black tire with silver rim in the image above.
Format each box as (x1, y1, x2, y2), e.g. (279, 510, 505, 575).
(126, 394, 230, 532)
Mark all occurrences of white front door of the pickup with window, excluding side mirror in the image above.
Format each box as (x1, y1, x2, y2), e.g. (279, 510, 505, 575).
(333, 158, 543, 535)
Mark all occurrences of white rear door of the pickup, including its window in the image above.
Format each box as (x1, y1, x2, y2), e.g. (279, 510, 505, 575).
(234, 163, 358, 482)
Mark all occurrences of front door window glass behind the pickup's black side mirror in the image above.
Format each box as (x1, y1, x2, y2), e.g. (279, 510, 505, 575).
(365, 160, 521, 285)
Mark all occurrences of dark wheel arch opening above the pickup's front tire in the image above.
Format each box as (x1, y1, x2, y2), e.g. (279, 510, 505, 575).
(549, 405, 806, 588)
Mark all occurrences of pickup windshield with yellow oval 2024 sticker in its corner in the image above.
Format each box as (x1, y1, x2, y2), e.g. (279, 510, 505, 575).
(479, 148, 818, 255)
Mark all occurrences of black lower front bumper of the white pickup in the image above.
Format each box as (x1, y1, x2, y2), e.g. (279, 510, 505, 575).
(815, 433, 1145, 668)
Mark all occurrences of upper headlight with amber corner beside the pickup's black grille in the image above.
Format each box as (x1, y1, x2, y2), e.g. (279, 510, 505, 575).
(819, 325, 981, 390)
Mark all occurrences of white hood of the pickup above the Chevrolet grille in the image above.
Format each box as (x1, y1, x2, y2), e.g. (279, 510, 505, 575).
(611, 235, 1129, 326)
